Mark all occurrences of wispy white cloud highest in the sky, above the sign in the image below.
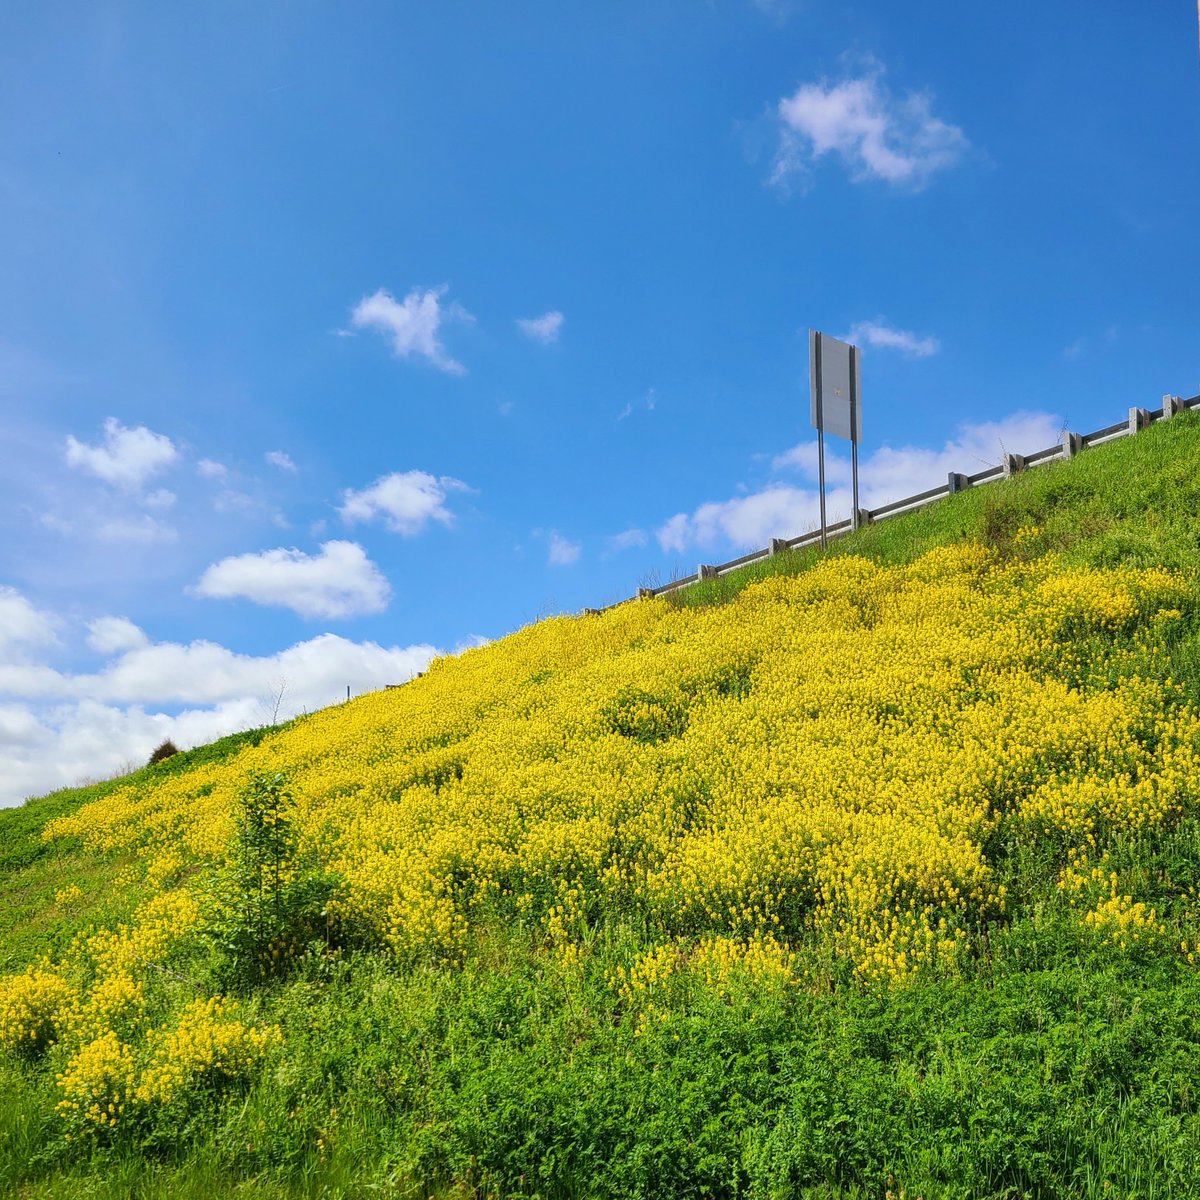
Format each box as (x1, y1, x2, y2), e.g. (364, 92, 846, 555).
(772, 61, 968, 190)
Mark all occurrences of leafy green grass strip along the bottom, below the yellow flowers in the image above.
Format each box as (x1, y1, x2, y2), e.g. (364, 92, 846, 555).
(7, 920, 1200, 1198)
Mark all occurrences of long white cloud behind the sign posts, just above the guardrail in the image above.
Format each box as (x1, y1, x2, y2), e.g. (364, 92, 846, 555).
(655, 413, 1061, 552)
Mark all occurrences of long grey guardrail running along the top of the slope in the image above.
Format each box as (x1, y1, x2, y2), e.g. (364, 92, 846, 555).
(630, 396, 1200, 599)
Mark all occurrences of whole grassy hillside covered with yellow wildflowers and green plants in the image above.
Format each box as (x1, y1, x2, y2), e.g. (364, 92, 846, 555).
(0, 414, 1200, 1198)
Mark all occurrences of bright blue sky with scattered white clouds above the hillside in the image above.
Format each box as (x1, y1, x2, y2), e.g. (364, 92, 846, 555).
(0, 0, 1200, 804)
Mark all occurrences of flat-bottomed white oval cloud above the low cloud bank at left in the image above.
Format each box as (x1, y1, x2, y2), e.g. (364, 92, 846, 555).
(192, 541, 391, 617)
